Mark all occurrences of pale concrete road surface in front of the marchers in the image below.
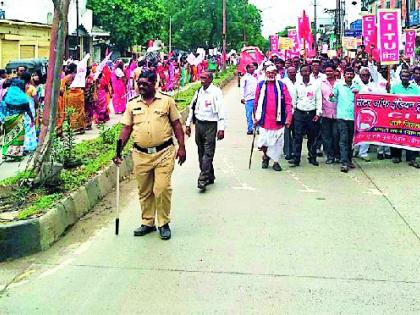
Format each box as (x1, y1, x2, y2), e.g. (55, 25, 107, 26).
(0, 84, 420, 314)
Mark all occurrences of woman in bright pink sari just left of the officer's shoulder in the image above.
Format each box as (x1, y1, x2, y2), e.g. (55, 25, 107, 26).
(111, 60, 127, 114)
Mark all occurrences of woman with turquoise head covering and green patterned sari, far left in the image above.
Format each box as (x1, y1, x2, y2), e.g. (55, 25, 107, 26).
(0, 78, 35, 160)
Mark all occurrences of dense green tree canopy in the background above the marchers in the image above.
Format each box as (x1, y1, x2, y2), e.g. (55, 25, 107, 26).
(88, 0, 268, 51)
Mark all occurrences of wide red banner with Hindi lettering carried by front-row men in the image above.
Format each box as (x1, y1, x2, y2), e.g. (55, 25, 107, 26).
(354, 94, 420, 151)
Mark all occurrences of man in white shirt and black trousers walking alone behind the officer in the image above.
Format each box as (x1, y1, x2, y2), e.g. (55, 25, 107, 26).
(186, 71, 225, 190)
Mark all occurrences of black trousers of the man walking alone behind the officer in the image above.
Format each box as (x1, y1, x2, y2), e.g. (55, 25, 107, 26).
(195, 120, 217, 182)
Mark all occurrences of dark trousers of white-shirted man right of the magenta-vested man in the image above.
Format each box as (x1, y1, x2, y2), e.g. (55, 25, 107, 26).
(293, 109, 319, 162)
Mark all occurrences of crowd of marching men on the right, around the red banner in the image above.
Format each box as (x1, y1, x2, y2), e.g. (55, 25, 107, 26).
(241, 50, 420, 172)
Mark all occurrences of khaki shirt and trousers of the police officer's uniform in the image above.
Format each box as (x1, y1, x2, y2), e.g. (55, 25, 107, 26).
(121, 93, 180, 227)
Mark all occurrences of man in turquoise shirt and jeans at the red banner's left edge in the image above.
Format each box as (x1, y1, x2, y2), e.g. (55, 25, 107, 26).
(330, 68, 360, 173)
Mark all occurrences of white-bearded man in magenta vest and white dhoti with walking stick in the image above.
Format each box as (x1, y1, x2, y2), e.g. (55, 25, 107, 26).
(254, 65, 292, 171)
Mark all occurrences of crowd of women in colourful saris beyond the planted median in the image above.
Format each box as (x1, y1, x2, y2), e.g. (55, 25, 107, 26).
(0, 51, 230, 160)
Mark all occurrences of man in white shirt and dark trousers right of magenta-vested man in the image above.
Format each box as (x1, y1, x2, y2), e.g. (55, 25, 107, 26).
(289, 65, 322, 167)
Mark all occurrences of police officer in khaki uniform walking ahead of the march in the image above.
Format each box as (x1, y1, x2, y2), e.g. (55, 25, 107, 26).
(114, 71, 186, 240)
